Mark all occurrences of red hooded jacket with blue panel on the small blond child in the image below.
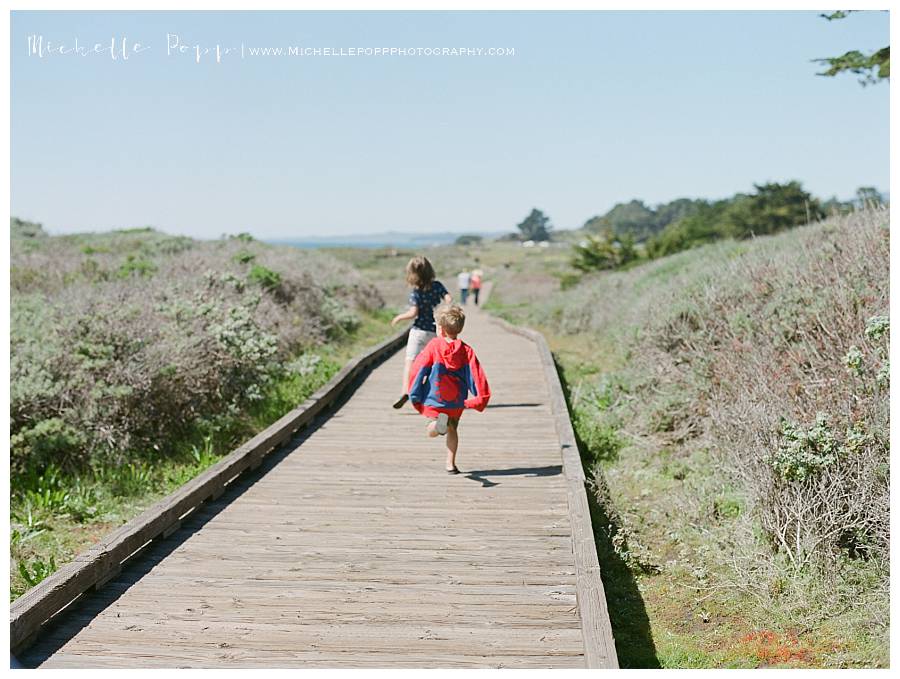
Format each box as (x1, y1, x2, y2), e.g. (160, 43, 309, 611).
(409, 337, 491, 417)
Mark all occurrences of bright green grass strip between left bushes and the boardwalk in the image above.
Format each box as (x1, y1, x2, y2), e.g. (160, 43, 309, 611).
(10, 310, 393, 601)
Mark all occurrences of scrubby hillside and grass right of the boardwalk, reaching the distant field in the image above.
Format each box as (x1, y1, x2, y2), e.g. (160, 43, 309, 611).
(335, 210, 889, 667)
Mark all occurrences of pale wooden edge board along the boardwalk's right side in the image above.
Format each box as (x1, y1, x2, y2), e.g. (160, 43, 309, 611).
(490, 315, 619, 669)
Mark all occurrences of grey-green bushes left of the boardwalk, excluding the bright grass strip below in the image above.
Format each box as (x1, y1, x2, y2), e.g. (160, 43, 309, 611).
(10, 229, 383, 474)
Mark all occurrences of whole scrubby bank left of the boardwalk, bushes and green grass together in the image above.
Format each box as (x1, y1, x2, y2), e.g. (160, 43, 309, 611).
(10, 220, 390, 598)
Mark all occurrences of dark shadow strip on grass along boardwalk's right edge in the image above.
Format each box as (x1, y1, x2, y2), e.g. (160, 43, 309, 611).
(556, 363, 661, 669)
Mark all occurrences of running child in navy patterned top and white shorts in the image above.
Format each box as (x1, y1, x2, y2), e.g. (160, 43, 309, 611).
(391, 257, 452, 408)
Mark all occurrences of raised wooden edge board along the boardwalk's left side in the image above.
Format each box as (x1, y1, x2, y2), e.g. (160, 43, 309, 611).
(9, 329, 409, 654)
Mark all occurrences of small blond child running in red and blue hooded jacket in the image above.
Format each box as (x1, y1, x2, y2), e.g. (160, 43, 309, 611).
(408, 304, 491, 474)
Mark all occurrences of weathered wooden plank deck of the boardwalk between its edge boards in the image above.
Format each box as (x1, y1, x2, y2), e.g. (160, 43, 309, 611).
(19, 306, 614, 668)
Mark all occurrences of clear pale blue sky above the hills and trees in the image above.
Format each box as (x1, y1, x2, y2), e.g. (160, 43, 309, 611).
(11, 12, 889, 238)
